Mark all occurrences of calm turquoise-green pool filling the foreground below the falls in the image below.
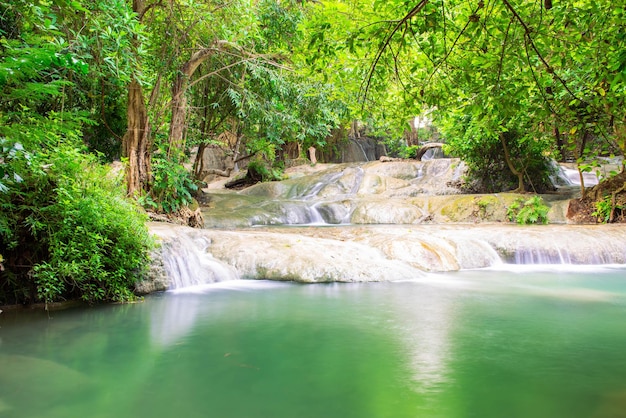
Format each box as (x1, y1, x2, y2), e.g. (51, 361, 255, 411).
(0, 269, 626, 418)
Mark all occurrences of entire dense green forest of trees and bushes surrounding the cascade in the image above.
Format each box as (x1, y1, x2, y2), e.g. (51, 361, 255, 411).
(0, 0, 626, 304)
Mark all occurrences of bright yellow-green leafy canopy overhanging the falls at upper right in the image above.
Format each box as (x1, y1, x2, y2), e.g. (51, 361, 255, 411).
(304, 0, 624, 193)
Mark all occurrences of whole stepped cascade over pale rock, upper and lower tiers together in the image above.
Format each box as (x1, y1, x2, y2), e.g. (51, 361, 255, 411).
(143, 160, 626, 289)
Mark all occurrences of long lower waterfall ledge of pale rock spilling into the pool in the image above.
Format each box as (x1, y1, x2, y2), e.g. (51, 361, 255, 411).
(151, 224, 626, 289)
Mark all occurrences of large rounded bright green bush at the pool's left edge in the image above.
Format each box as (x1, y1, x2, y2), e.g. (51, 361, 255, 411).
(0, 146, 152, 303)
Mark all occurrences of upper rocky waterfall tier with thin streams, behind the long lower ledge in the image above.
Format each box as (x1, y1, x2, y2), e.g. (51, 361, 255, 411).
(203, 159, 464, 227)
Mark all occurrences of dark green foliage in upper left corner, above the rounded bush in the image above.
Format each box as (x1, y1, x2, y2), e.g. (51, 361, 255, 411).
(0, 0, 143, 160)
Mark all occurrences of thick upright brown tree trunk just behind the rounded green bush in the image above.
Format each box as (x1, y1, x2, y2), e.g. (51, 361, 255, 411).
(122, 79, 151, 196)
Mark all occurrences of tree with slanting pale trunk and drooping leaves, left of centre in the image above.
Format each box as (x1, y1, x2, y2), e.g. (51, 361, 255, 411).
(152, 0, 344, 182)
